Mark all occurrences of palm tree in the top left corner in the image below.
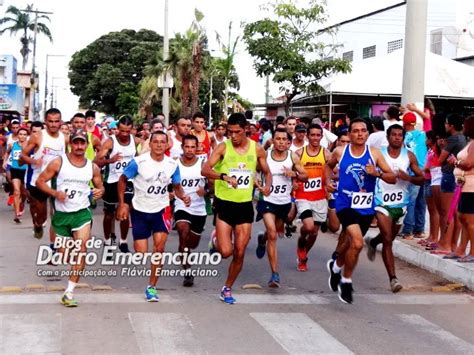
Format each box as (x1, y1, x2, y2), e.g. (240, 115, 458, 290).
(0, 4, 53, 70)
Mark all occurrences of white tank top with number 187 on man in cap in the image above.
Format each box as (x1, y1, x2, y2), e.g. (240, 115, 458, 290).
(54, 154, 94, 212)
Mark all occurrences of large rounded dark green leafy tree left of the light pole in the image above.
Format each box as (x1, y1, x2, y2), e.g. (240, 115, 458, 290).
(69, 29, 163, 114)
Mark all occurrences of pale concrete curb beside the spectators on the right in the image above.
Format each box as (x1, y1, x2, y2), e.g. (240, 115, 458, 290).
(393, 240, 474, 291)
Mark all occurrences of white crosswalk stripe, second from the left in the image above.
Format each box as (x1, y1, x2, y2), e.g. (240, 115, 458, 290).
(128, 312, 204, 354)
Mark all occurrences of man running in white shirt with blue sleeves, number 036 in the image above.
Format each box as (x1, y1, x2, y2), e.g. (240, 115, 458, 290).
(117, 131, 191, 302)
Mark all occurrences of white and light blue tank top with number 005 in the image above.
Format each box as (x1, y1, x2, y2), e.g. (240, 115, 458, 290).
(375, 147, 410, 208)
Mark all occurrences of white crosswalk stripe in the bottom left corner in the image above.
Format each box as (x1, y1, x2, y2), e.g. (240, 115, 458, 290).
(0, 313, 62, 354)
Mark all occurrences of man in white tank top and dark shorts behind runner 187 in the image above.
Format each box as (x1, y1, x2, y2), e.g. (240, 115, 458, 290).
(20, 108, 68, 244)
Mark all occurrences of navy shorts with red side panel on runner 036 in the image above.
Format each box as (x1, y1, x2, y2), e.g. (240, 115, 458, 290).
(130, 207, 171, 240)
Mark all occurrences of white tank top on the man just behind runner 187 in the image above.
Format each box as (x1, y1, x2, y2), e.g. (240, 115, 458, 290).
(31, 129, 66, 186)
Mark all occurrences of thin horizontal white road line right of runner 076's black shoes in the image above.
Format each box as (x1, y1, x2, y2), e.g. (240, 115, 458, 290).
(364, 294, 474, 305)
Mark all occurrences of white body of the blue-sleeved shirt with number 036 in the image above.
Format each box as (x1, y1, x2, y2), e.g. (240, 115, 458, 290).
(132, 152, 178, 213)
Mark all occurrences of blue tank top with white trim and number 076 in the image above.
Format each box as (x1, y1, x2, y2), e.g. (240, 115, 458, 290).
(336, 144, 376, 215)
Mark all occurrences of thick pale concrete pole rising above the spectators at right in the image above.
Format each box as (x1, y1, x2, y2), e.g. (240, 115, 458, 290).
(402, 0, 428, 129)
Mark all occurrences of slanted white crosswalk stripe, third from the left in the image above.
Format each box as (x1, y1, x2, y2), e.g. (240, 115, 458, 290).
(250, 313, 353, 354)
